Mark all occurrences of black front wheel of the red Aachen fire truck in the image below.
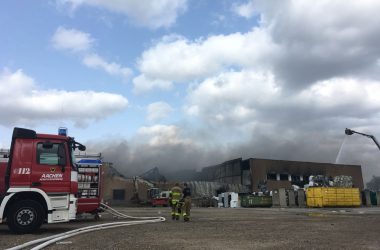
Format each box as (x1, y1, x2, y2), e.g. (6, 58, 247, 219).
(7, 200, 45, 234)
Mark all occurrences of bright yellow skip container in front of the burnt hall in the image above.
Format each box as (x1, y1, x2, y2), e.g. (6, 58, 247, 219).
(306, 187, 361, 207)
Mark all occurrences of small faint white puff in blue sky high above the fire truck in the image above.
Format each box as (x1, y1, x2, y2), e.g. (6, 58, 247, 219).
(51, 27, 94, 52)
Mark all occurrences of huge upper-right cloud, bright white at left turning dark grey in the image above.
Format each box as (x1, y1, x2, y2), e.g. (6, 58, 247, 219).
(137, 0, 380, 89)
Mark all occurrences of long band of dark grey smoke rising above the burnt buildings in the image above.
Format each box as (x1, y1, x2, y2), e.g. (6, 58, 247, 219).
(87, 129, 380, 185)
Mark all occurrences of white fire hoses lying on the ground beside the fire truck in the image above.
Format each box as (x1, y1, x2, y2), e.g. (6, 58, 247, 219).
(8, 203, 166, 250)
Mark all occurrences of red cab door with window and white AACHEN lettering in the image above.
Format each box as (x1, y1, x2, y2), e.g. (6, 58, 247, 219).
(31, 140, 71, 193)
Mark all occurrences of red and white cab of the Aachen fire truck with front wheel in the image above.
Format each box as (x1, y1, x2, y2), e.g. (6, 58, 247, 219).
(0, 128, 86, 233)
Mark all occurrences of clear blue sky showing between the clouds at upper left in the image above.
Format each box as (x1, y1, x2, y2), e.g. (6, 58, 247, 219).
(0, 1, 252, 141)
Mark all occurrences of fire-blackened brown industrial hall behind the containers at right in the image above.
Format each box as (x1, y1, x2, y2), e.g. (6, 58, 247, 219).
(200, 158, 364, 192)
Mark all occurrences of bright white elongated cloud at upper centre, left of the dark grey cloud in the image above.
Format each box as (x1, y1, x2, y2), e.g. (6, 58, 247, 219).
(138, 29, 276, 84)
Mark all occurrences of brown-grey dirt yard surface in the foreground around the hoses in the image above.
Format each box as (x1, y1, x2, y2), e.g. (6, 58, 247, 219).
(0, 207, 380, 250)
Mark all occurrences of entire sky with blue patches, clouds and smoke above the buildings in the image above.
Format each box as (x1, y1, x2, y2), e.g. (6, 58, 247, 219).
(0, 0, 380, 179)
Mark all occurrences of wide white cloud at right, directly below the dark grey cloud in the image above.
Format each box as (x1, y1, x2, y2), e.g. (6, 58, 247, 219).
(185, 71, 380, 131)
